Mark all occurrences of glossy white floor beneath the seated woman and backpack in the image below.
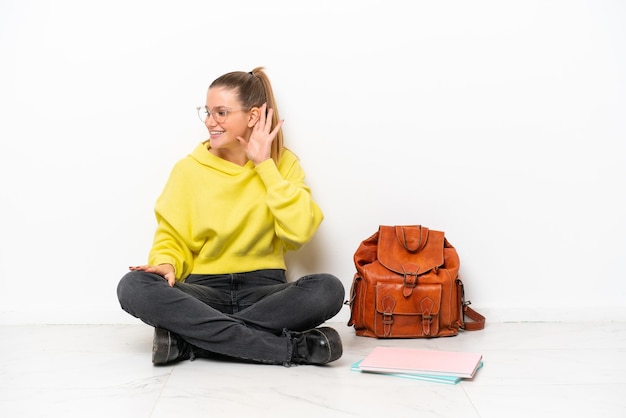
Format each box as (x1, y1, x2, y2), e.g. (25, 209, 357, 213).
(0, 323, 626, 418)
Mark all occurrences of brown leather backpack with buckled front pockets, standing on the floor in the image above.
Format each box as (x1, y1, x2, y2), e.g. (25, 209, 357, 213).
(346, 225, 485, 338)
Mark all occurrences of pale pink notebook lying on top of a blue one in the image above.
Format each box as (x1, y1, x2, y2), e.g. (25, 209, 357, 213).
(359, 347, 483, 378)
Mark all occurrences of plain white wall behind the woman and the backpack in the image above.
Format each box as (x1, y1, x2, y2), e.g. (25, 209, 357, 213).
(0, 0, 626, 323)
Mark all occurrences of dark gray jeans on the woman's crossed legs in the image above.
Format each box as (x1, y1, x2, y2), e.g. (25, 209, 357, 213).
(117, 270, 345, 364)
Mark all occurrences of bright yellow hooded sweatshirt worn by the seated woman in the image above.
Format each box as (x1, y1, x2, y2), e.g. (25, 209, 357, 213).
(148, 143, 323, 280)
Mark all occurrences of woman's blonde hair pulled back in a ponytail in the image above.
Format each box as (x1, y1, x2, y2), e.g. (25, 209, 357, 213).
(209, 67, 284, 164)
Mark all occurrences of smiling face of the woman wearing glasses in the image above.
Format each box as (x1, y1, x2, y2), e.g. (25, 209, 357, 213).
(204, 87, 250, 152)
